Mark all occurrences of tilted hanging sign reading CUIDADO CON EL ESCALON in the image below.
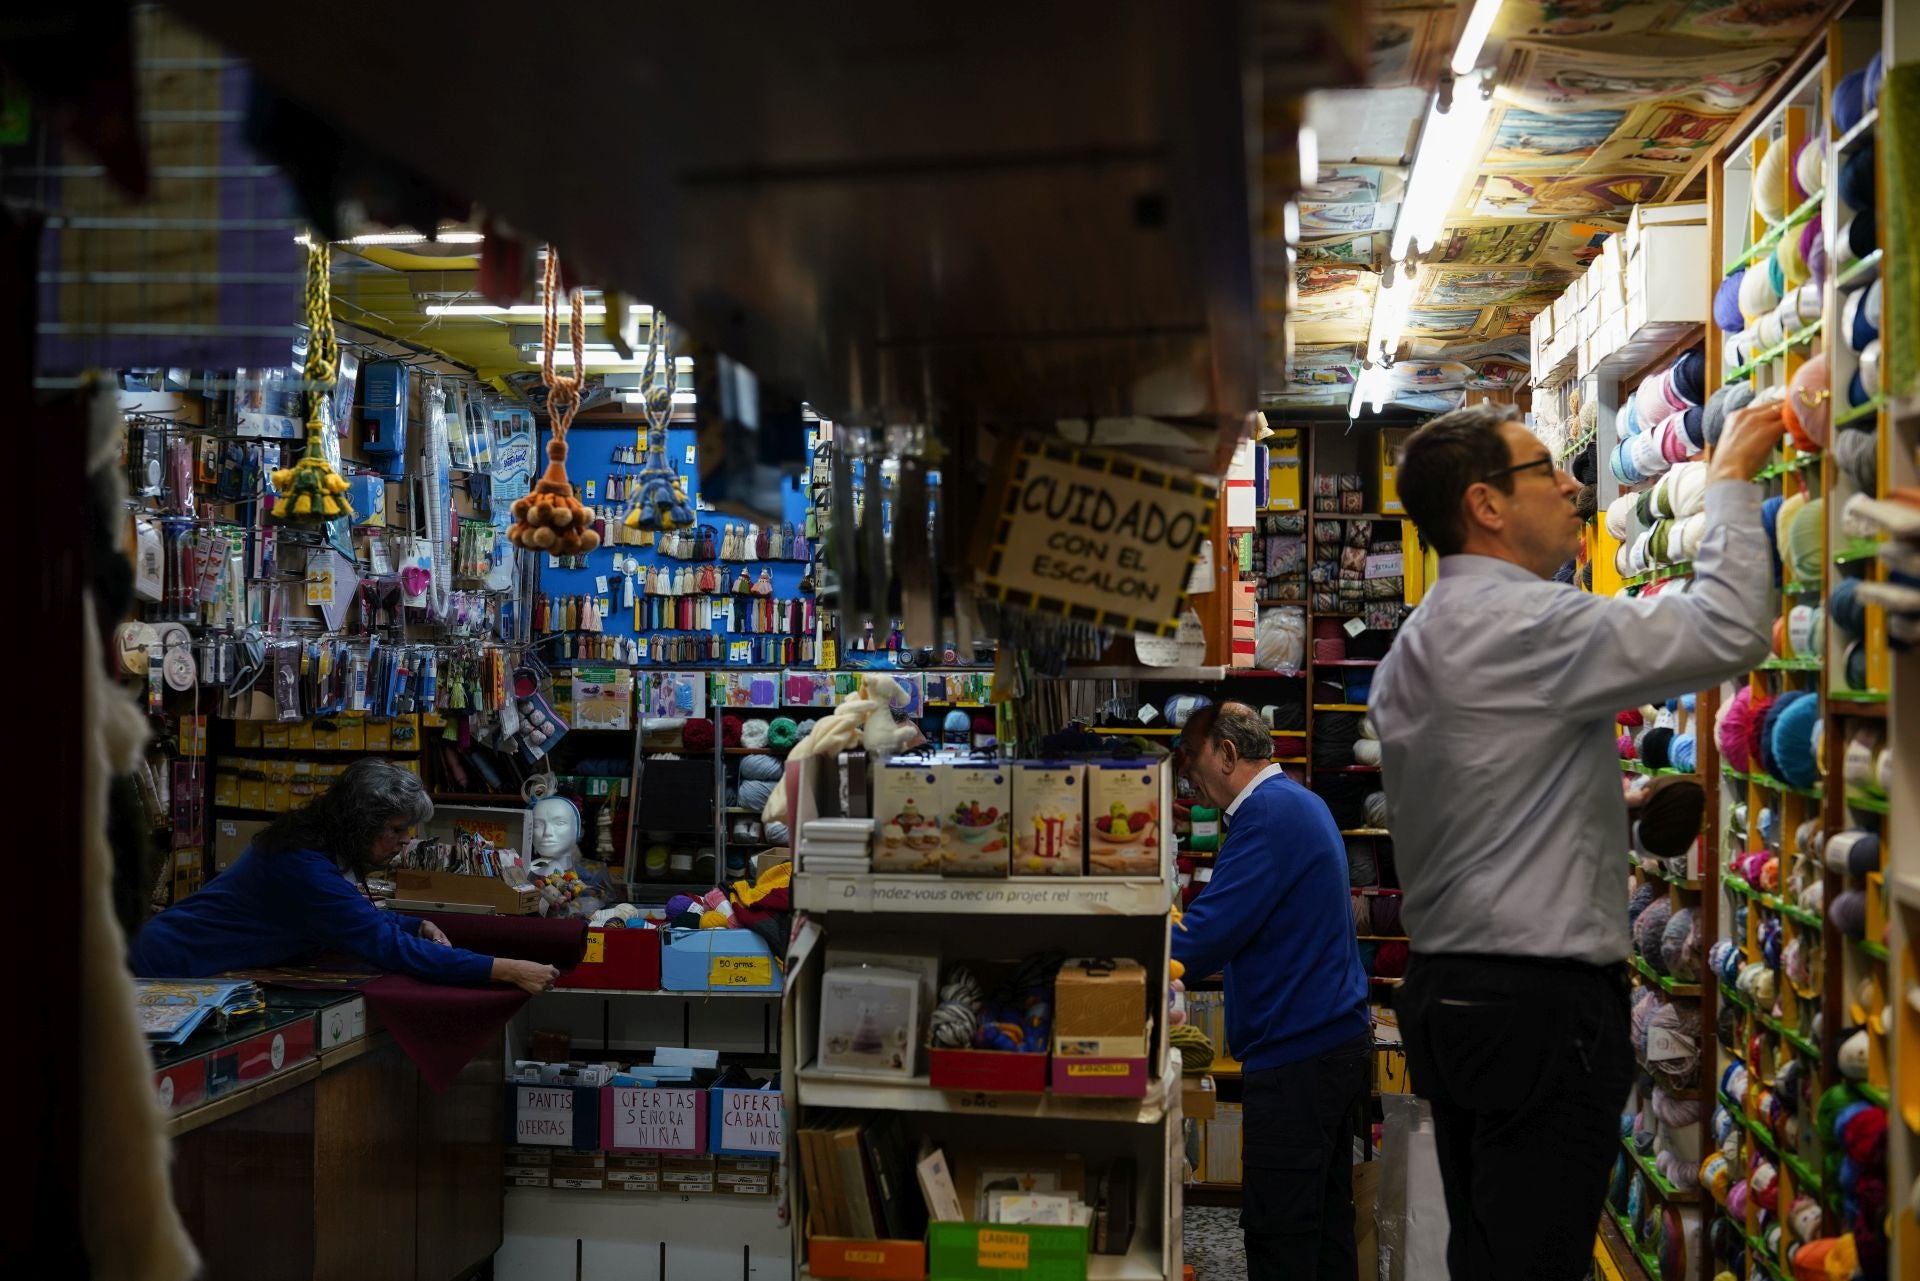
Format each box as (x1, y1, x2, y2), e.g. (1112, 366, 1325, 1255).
(973, 440, 1219, 636)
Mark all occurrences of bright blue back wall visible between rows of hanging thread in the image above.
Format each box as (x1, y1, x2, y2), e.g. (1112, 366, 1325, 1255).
(536, 423, 812, 666)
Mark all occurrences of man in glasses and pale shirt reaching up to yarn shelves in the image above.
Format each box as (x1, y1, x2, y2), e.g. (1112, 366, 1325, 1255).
(1369, 395, 1782, 1281)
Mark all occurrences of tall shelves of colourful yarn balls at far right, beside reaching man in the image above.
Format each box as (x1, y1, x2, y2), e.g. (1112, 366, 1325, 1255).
(1699, 23, 1905, 1279)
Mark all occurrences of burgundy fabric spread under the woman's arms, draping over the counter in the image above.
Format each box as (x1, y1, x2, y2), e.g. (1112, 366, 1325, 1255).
(361, 912, 588, 1093)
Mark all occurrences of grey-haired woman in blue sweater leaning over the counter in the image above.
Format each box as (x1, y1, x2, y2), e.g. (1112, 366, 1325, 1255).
(129, 759, 559, 993)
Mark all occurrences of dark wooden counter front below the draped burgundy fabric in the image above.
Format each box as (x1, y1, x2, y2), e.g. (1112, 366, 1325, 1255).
(171, 1033, 505, 1281)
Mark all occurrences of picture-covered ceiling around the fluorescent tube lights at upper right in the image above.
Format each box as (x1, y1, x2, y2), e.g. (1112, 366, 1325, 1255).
(1263, 0, 1839, 419)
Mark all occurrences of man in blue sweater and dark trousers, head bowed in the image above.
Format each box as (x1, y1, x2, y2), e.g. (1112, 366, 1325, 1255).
(1173, 703, 1373, 1281)
